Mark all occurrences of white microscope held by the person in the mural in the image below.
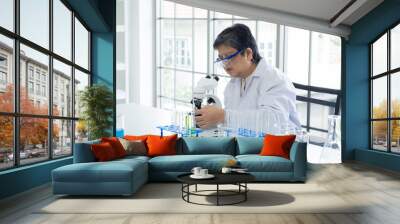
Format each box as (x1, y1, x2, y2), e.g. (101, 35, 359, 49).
(191, 75, 222, 128)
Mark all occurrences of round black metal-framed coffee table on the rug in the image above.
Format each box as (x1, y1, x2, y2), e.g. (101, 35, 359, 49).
(177, 173, 255, 206)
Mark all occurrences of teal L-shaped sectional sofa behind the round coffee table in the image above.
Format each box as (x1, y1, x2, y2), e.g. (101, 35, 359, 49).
(52, 137, 307, 195)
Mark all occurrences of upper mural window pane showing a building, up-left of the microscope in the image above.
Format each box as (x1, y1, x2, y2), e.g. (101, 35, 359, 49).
(175, 20, 193, 70)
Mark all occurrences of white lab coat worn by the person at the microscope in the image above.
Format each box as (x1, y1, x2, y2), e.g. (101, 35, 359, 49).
(224, 59, 301, 133)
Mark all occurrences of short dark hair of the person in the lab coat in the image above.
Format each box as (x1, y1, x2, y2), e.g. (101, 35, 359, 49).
(213, 23, 262, 64)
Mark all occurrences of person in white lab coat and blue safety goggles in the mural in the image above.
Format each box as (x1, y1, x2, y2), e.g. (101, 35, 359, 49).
(196, 24, 300, 129)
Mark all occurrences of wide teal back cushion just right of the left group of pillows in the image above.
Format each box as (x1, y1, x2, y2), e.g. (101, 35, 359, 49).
(181, 137, 235, 155)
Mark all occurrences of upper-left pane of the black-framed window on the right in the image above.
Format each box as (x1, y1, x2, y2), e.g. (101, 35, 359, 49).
(372, 34, 387, 75)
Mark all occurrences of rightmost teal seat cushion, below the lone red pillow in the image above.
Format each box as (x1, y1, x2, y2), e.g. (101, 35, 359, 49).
(236, 155, 293, 172)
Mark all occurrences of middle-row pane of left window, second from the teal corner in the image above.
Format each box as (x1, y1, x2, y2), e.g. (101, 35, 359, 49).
(53, 59, 72, 117)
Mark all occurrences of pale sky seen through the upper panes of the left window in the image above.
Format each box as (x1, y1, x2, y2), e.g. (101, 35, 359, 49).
(0, 0, 88, 72)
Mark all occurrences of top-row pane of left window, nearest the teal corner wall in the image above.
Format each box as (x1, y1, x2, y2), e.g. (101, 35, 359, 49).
(75, 18, 89, 69)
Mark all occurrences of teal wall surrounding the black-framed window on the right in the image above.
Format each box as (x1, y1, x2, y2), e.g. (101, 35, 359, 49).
(343, 0, 400, 169)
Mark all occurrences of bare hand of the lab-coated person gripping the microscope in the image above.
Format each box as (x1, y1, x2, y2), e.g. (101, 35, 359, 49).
(195, 106, 225, 129)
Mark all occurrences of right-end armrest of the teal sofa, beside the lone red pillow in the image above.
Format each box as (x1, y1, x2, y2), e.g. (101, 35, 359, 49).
(290, 142, 307, 181)
